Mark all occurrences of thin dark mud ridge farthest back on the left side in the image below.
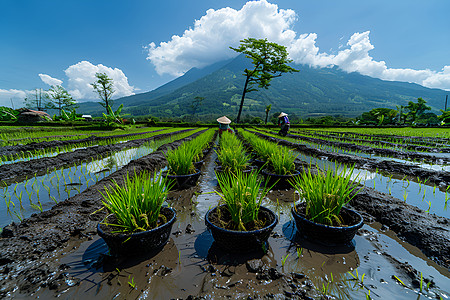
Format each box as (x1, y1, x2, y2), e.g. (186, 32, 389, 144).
(0, 129, 165, 156)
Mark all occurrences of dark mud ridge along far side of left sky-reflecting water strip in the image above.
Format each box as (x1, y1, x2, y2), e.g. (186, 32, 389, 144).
(0, 129, 189, 184)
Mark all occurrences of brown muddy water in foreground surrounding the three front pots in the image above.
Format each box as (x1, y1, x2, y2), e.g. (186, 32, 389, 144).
(33, 149, 450, 299)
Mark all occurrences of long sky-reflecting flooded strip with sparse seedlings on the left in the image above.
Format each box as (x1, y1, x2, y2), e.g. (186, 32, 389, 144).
(0, 132, 196, 228)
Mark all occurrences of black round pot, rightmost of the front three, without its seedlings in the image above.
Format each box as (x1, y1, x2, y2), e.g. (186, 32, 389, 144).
(291, 203, 364, 246)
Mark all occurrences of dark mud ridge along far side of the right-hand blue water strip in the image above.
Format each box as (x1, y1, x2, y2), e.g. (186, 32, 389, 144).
(251, 132, 450, 187)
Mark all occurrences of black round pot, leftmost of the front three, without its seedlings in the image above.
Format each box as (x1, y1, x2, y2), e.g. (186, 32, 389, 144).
(97, 207, 177, 256)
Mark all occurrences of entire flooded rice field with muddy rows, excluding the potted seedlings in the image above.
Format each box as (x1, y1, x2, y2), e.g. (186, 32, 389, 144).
(0, 127, 450, 299)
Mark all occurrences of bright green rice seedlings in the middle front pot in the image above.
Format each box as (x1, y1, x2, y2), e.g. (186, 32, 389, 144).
(216, 172, 269, 231)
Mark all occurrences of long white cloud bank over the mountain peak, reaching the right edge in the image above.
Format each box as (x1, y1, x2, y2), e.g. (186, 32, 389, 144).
(147, 0, 450, 90)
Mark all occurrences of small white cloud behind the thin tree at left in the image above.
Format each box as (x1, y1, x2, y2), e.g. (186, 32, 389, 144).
(64, 61, 135, 100)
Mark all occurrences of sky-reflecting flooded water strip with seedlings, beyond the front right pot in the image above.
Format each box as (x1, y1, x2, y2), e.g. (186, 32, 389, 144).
(297, 152, 450, 218)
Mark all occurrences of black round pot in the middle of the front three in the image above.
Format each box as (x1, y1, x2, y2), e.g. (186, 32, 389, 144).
(205, 205, 278, 252)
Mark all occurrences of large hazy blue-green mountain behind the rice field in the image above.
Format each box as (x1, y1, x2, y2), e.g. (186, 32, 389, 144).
(77, 56, 447, 118)
